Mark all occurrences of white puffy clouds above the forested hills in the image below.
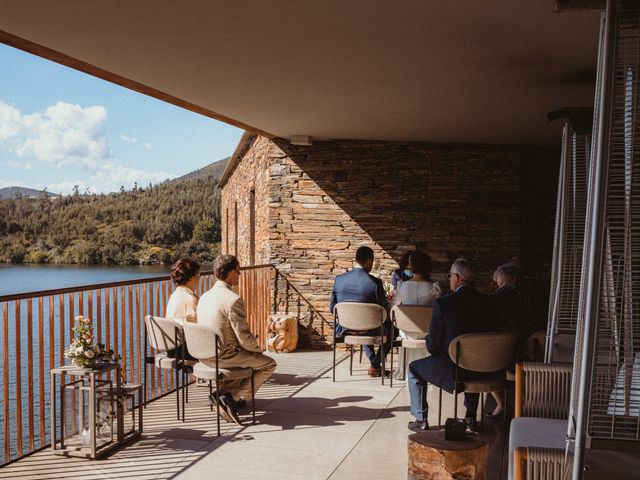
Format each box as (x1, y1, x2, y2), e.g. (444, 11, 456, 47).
(0, 100, 175, 193)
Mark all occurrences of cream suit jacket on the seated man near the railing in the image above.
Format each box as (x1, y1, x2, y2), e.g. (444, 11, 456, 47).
(197, 280, 262, 359)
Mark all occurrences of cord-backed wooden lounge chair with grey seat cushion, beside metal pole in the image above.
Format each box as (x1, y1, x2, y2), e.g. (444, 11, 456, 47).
(509, 362, 572, 480)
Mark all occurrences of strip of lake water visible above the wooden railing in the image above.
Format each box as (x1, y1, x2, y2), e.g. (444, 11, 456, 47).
(0, 263, 170, 296)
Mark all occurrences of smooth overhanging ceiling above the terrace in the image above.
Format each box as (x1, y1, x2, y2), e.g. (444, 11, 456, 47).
(0, 0, 600, 144)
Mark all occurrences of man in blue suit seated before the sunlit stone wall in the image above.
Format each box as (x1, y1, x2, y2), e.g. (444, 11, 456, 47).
(329, 246, 392, 377)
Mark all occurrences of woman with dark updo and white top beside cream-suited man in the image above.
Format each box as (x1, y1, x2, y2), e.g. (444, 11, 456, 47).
(165, 258, 200, 323)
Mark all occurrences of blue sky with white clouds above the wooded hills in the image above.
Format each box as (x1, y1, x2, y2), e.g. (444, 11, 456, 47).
(0, 44, 242, 194)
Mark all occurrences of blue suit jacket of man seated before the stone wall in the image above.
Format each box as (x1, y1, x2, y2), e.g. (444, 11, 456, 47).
(329, 268, 389, 336)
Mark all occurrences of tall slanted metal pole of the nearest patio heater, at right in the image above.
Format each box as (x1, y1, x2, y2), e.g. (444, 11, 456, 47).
(572, 0, 616, 480)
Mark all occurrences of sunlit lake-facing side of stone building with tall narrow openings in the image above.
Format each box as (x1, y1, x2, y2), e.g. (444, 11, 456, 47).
(220, 137, 274, 265)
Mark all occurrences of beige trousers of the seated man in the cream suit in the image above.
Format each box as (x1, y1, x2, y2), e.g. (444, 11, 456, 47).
(201, 350, 276, 400)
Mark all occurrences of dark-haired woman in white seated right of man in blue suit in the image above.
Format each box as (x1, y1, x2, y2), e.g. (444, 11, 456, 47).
(391, 250, 442, 380)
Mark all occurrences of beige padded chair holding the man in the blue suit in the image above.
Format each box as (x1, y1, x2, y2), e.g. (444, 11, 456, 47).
(333, 302, 387, 385)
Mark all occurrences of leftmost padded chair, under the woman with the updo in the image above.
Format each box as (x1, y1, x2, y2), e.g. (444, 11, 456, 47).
(144, 315, 195, 421)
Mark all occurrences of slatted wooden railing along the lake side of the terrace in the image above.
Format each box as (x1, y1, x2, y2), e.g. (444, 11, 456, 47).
(0, 265, 273, 466)
